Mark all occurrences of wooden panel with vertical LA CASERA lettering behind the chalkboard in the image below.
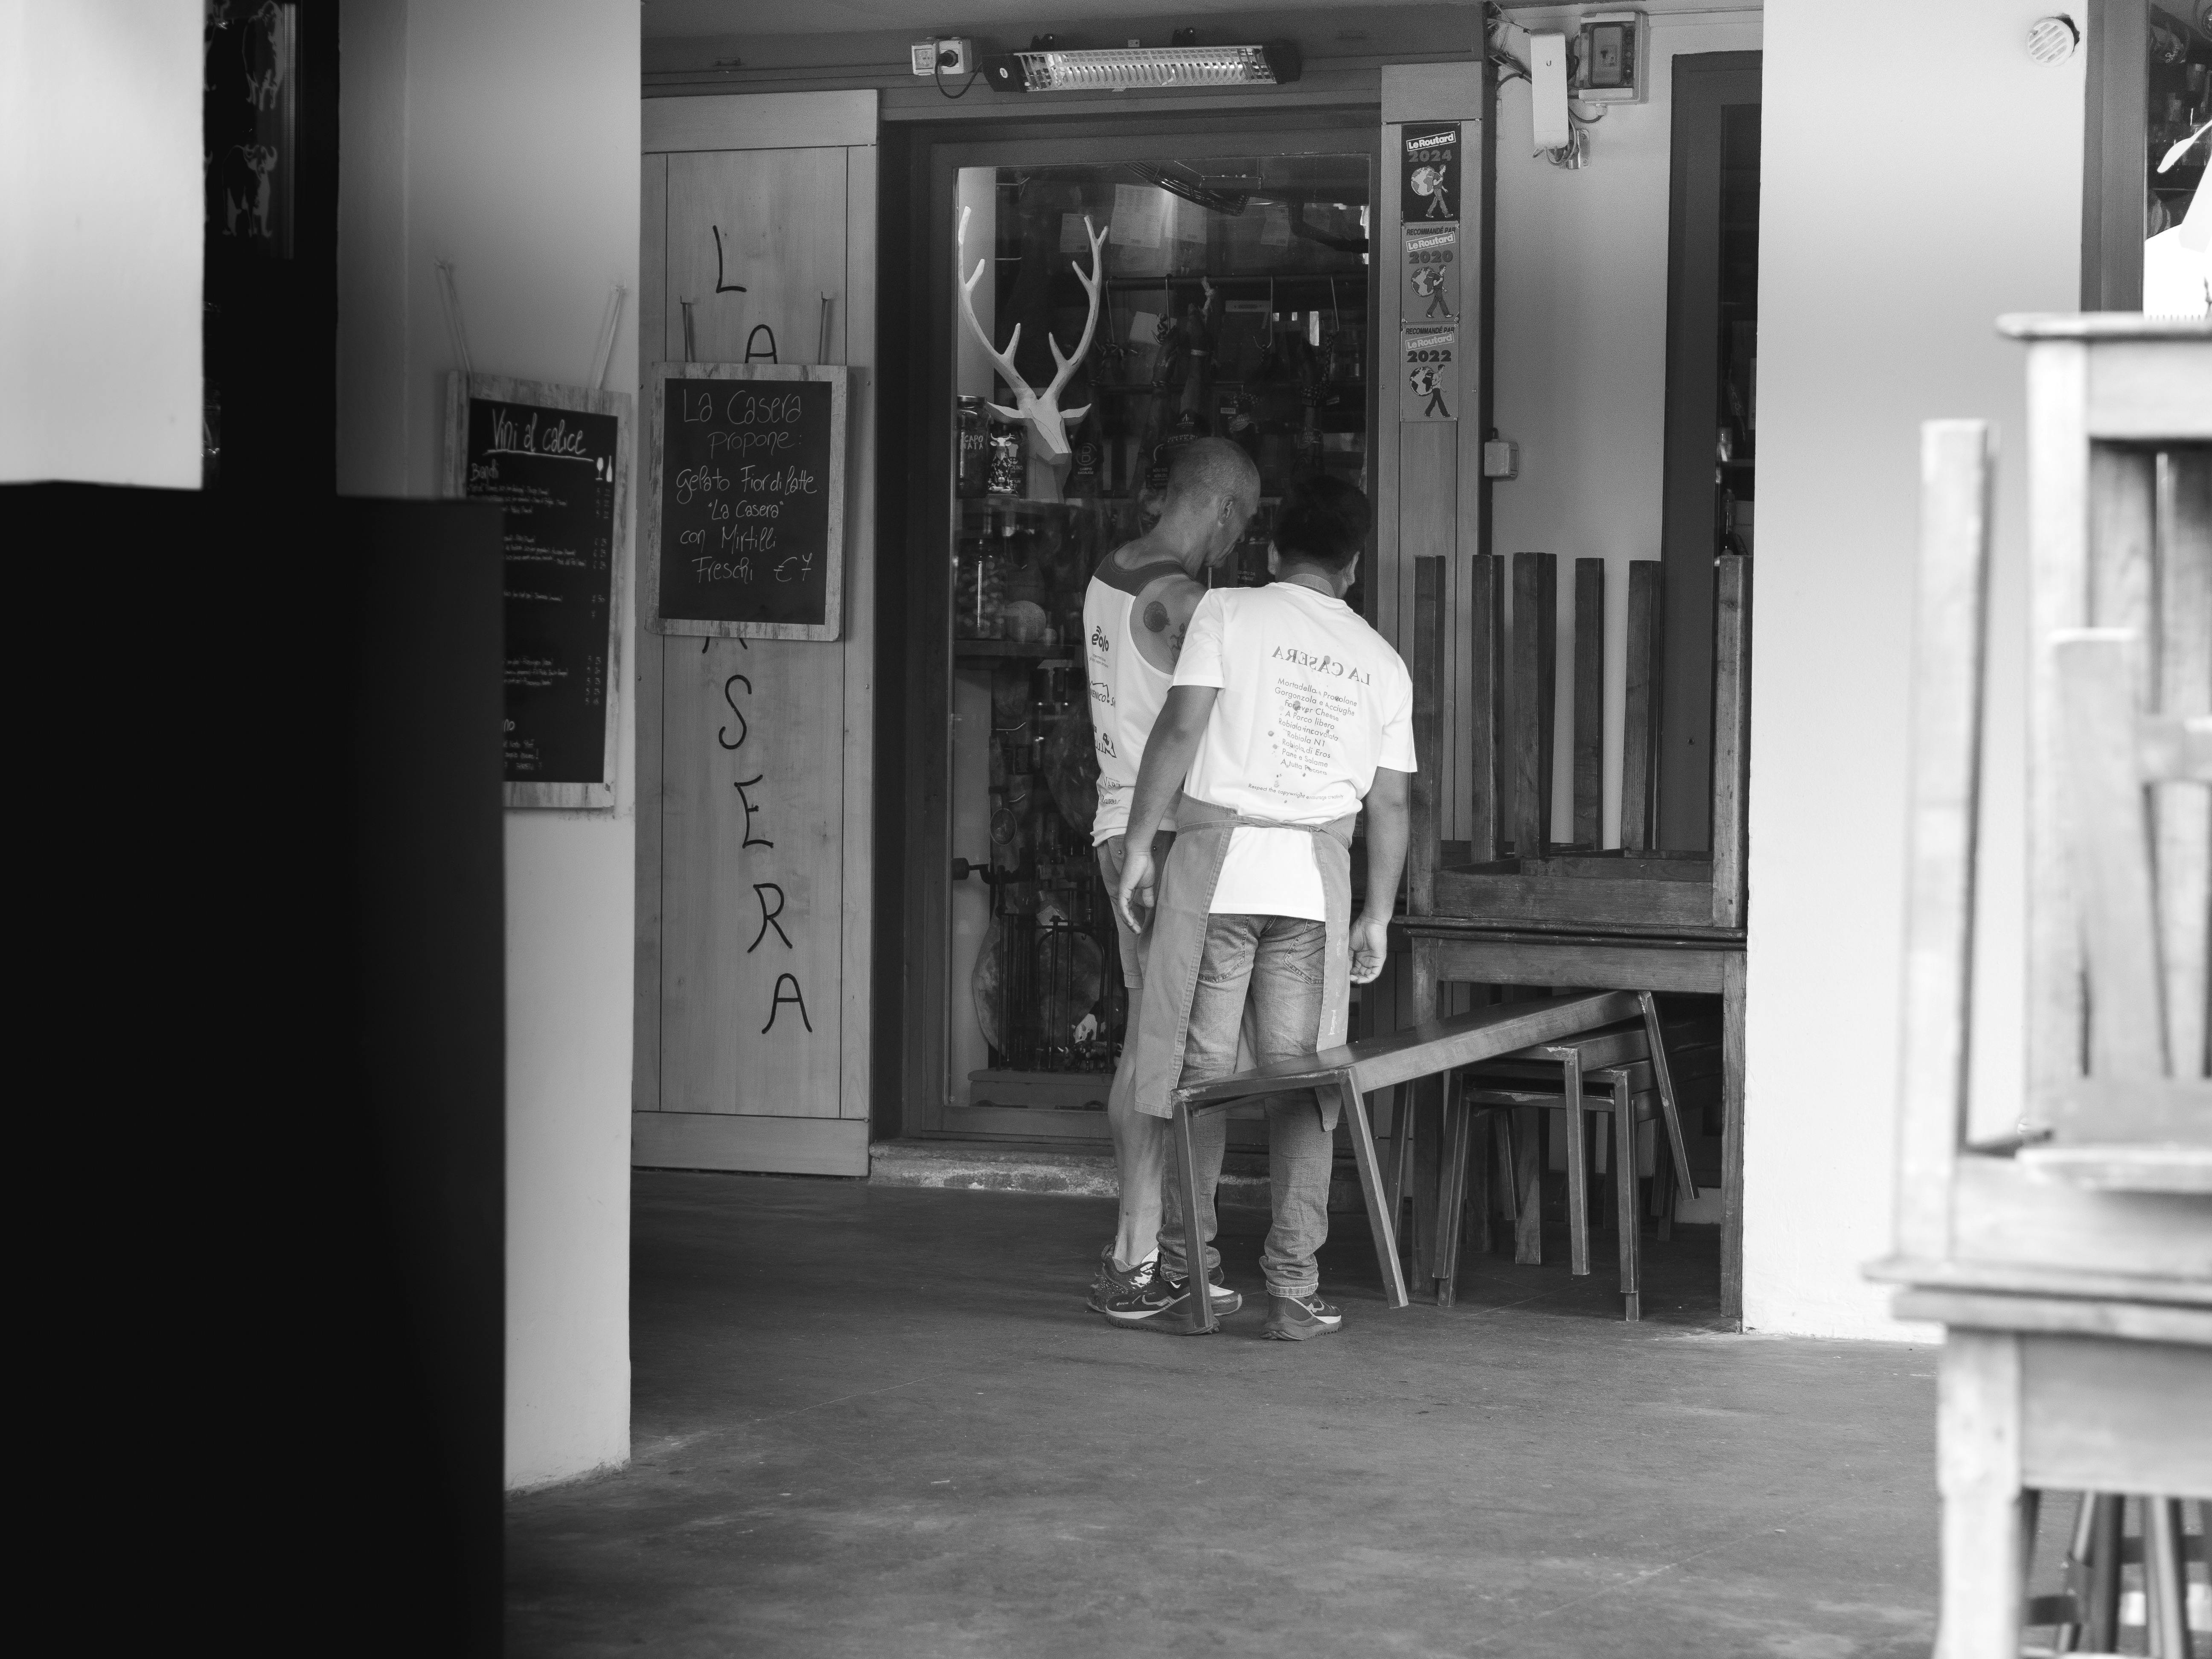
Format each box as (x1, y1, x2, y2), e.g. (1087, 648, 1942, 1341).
(659, 148, 847, 1117)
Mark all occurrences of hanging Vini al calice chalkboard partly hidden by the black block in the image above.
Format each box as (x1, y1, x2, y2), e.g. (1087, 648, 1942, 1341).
(445, 374, 630, 807)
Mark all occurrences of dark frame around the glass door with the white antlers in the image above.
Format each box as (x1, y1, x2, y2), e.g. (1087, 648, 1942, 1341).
(876, 104, 1382, 1146)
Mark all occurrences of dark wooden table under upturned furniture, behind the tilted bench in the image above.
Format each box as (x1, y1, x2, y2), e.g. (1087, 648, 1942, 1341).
(1394, 916, 1743, 1321)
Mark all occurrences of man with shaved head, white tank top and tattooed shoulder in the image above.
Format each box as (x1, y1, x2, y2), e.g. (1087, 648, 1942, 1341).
(1084, 438, 1259, 1330)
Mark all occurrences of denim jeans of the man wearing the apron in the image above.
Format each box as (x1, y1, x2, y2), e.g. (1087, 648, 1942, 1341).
(1159, 916, 1336, 1296)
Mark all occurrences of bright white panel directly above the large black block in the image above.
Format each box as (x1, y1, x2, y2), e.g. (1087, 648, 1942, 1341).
(0, 0, 201, 489)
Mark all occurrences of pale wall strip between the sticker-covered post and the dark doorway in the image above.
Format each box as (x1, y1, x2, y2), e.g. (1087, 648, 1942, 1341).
(1491, 9, 1765, 847)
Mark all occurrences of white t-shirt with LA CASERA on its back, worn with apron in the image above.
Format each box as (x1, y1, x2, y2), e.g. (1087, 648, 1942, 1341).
(1175, 582, 1416, 923)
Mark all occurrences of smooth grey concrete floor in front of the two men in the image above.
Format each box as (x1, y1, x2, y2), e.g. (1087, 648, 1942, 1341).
(506, 1173, 1936, 1659)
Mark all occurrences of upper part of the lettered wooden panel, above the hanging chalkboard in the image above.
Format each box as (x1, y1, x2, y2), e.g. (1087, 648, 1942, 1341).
(664, 148, 847, 363)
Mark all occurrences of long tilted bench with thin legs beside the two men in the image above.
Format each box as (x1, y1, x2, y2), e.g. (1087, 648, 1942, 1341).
(1173, 991, 1644, 1334)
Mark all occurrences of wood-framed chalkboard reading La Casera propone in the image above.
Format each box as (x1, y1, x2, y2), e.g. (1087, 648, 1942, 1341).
(644, 363, 847, 639)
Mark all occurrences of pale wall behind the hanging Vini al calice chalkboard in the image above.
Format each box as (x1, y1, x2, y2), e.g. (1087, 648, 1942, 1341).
(338, 0, 639, 1487)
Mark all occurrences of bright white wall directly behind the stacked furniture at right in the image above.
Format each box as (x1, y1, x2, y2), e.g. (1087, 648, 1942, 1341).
(1743, 0, 2084, 1336)
